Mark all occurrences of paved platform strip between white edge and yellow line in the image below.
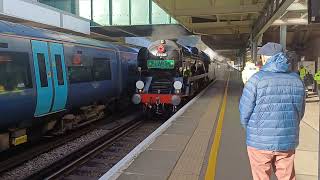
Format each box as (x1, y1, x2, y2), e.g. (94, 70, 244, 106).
(118, 81, 225, 180)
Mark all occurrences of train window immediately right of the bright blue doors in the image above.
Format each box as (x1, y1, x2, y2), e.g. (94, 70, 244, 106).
(69, 66, 93, 84)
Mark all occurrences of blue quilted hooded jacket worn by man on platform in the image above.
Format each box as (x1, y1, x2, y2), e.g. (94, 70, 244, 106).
(239, 53, 305, 151)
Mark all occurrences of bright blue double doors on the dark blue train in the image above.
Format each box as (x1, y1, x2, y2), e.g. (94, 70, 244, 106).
(31, 40, 67, 117)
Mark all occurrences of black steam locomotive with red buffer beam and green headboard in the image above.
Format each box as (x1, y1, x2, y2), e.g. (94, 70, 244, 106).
(132, 40, 215, 115)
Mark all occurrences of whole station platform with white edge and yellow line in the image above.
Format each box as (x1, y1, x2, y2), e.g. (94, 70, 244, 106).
(100, 71, 319, 180)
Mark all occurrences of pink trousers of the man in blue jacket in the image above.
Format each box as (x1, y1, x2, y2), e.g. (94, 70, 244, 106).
(247, 146, 296, 180)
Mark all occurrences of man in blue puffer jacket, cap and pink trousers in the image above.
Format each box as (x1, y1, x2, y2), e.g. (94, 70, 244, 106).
(239, 43, 305, 180)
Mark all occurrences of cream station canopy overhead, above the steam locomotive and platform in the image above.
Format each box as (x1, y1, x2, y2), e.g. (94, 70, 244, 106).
(154, 0, 307, 49)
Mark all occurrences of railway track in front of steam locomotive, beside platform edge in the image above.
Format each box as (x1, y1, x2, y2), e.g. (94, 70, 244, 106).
(44, 120, 162, 180)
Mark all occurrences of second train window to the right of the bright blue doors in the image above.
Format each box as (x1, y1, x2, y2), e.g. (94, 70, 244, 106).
(93, 58, 111, 81)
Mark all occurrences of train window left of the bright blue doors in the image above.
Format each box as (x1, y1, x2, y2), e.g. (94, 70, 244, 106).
(0, 52, 32, 93)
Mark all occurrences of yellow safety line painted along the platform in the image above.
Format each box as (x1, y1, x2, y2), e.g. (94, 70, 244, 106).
(205, 74, 230, 180)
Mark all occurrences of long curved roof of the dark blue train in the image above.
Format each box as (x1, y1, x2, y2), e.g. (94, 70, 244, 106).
(0, 21, 137, 52)
